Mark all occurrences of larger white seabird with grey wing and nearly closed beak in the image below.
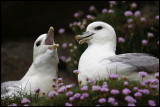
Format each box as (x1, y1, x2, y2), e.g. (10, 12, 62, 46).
(76, 21, 159, 85)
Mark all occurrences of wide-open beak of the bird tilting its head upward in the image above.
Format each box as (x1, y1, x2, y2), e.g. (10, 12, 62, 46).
(45, 26, 59, 50)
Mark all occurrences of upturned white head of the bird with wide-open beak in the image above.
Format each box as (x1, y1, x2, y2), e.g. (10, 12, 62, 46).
(33, 27, 59, 64)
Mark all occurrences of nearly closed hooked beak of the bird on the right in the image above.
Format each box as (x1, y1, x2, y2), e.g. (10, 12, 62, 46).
(75, 31, 94, 44)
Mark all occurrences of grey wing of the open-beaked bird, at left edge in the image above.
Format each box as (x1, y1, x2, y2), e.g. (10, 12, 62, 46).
(1, 81, 20, 95)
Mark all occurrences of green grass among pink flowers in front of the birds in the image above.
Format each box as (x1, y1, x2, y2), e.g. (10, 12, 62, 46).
(1, 79, 159, 106)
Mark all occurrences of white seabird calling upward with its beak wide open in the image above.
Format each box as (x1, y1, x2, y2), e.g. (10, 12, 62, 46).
(1, 27, 59, 97)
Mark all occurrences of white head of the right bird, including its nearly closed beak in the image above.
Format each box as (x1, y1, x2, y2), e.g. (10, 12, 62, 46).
(76, 21, 116, 50)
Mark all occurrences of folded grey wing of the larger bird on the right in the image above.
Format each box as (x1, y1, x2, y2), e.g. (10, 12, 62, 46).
(107, 53, 159, 73)
